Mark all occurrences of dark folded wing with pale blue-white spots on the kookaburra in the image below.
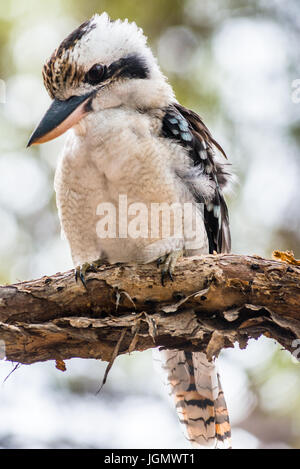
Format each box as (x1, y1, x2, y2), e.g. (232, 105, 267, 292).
(162, 103, 231, 253)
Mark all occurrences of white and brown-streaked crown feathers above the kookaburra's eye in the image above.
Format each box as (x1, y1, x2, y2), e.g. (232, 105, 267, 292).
(43, 13, 165, 100)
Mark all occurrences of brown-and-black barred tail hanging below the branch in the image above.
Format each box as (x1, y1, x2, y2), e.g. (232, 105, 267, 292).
(160, 350, 231, 449)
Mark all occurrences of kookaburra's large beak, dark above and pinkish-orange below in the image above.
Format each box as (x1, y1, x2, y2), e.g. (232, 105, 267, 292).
(27, 91, 94, 147)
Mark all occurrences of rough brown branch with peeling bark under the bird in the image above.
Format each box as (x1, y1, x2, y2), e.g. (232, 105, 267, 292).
(0, 254, 300, 364)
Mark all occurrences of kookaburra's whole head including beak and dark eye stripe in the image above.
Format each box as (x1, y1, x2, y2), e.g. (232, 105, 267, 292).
(28, 13, 173, 146)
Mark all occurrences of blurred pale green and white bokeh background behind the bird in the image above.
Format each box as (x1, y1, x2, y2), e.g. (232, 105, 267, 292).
(0, 0, 300, 448)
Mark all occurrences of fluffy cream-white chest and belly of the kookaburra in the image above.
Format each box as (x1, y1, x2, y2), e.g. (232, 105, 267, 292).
(55, 107, 206, 264)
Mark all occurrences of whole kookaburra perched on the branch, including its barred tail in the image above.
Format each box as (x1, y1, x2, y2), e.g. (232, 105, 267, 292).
(28, 13, 230, 448)
